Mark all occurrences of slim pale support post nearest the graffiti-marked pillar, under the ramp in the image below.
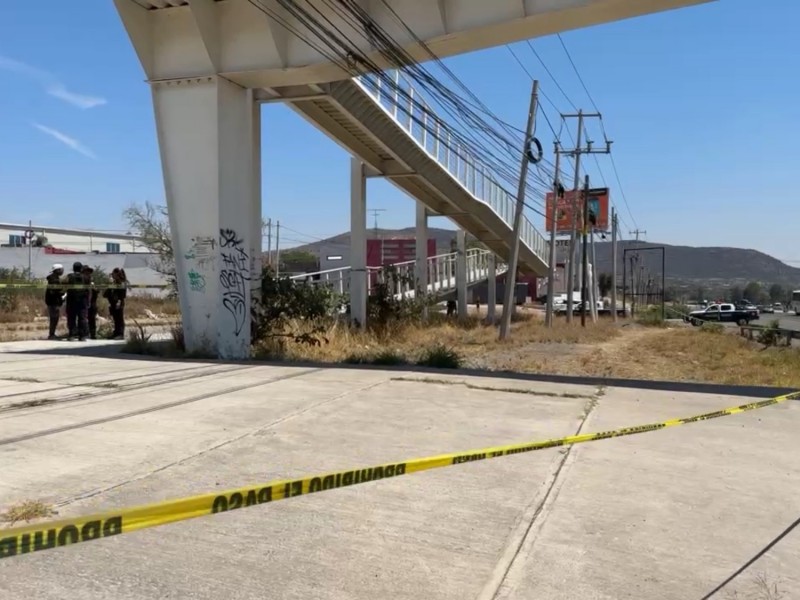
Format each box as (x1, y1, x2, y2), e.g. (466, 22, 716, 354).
(350, 156, 368, 328)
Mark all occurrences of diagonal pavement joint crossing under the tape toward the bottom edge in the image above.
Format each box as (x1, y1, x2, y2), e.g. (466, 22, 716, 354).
(475, 380, 599, 600)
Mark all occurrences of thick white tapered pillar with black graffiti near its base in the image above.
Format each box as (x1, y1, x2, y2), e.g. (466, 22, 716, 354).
(152, 76, 261, 359)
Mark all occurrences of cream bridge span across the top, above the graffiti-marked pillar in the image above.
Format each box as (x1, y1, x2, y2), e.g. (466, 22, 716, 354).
(119, 0, 713, 88)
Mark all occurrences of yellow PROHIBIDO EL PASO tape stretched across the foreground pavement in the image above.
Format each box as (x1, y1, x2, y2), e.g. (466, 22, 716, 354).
(0, 392, 800, 558)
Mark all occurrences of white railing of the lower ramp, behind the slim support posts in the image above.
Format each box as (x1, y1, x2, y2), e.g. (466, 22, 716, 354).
(290, 248, 506, 297)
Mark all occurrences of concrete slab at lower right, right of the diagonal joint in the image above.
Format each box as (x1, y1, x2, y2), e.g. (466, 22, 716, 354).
(496, 390, 800, 600)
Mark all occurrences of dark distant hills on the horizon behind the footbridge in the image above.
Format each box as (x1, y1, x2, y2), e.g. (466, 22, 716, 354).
(296, 227, 800, 289)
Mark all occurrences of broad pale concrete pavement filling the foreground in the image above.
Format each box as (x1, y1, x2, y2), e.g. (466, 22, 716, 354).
(0, 345, 800, 600)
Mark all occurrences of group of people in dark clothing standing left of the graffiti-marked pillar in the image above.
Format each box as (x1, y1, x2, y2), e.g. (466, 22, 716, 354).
(44, 262, 128, 341)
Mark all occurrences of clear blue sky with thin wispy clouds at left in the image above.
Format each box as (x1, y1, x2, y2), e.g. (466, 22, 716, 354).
(0, 0, 800, 266)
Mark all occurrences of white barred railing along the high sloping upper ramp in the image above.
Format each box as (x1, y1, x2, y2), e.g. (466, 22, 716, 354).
(354, 69, 550, 263)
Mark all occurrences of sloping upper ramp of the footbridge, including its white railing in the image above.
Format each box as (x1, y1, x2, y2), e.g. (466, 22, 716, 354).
(269, 70, 549, 276)
